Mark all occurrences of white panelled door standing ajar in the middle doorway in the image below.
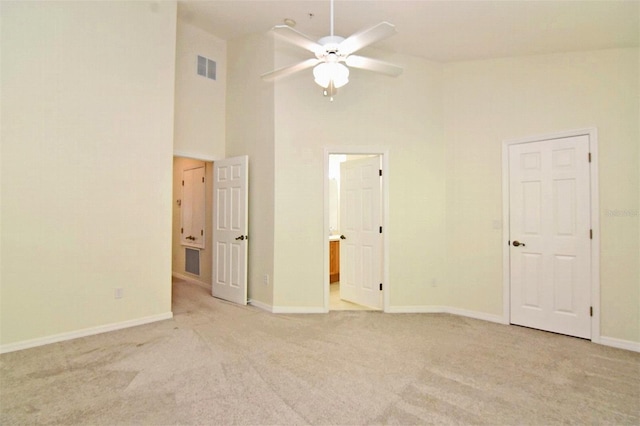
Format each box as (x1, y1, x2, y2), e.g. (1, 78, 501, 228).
(340, 156, 382, 309)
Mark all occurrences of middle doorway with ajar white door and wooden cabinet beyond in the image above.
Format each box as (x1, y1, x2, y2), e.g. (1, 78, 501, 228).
(324, 147, 389, 312)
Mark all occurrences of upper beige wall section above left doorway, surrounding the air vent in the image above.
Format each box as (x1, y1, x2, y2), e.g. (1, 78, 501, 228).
(173, 18, 227, 160)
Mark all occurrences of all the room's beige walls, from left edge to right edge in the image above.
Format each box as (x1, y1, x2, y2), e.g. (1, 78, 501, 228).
(0, 2, 640, 345)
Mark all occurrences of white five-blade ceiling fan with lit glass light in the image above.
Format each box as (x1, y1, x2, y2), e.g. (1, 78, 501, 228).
(262, 0, 402, 100)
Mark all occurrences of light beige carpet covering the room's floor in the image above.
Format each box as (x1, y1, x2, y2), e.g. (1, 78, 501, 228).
(0, 282, 640, 425)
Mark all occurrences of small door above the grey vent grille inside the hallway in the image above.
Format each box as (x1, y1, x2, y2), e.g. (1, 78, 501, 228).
(180, 167, 205, 248)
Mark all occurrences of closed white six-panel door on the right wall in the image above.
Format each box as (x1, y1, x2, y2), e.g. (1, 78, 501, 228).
(509, 135, 591, 338)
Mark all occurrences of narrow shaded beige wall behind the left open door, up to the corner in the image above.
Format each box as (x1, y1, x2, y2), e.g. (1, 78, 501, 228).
(226, 35, 277, 306)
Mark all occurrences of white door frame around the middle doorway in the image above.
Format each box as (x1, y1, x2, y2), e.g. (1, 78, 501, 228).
(322, 146, 391, 313)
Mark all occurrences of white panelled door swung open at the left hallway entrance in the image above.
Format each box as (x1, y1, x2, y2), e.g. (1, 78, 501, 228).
(211, 156, 249, 305)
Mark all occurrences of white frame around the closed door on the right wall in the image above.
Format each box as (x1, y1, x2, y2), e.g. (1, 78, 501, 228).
(502, 127, 600, 343)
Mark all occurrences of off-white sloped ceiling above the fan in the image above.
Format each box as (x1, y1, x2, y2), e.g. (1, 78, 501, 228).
(179, 0, 640, 62)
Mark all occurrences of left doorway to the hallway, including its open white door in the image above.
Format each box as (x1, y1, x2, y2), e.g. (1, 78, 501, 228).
(171, 155, 248, 305)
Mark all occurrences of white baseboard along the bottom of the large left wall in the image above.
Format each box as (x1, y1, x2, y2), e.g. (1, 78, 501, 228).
(0, 312, 173, 354)
